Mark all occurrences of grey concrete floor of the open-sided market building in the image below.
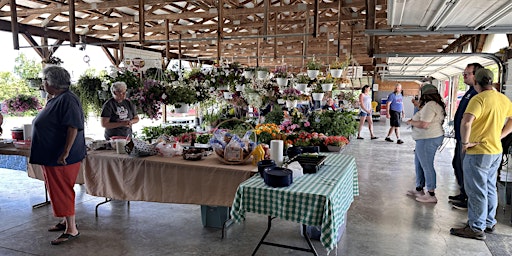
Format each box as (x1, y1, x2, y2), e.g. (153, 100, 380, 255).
(0, 121, 512, 256)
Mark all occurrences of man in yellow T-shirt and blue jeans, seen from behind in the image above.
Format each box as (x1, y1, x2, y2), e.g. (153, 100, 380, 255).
(450, 69, 512, 240)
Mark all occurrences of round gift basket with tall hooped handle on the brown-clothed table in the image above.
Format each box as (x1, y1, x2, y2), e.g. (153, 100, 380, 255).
(210, 119, 256, 164)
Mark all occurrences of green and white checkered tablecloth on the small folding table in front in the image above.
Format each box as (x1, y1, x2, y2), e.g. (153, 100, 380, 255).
(231, 154, 359, 250)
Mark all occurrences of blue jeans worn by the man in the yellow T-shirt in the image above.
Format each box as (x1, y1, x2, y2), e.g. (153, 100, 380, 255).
(462, 154, 501, 231)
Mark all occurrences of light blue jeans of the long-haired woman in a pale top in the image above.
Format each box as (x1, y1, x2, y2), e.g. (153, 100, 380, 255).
(414, 136, 444, 190)
